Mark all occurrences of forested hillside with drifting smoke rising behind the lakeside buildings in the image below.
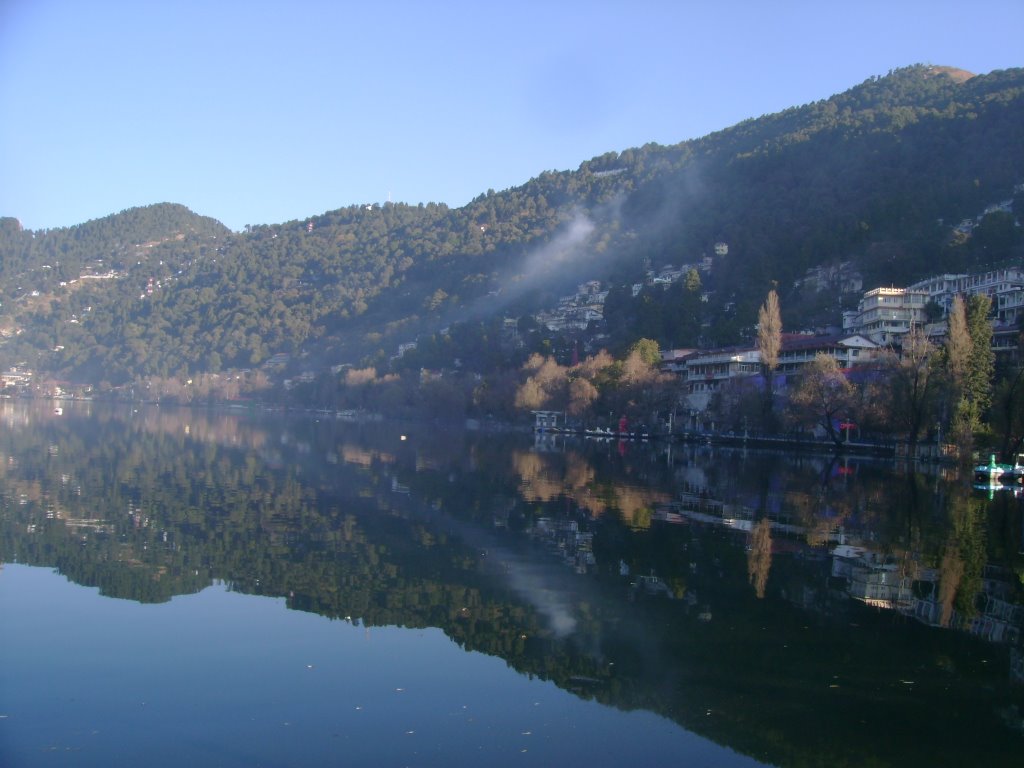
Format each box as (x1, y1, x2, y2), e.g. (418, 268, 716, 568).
(0, 66, 1024, 391)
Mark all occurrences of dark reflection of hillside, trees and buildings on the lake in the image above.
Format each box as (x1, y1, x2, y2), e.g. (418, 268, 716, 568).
(0, 401, 1024, 765)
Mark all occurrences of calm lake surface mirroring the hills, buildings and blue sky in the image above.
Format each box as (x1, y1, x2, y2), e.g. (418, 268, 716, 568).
(0, 401, 1024, 766)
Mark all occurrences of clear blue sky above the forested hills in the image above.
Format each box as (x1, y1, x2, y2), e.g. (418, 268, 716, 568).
(0, 0, 1024, 229)
